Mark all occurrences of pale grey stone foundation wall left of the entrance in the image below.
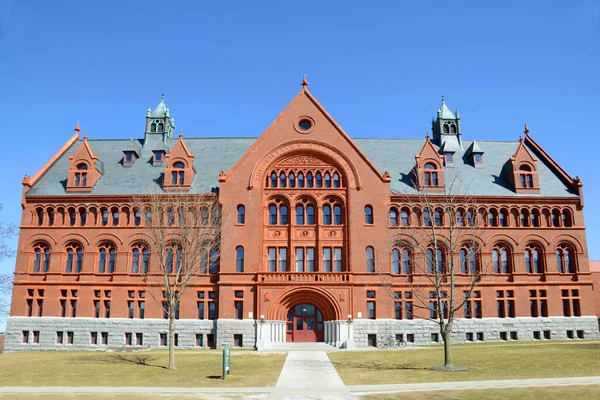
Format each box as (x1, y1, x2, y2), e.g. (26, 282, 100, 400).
(5, 317, 256, 352)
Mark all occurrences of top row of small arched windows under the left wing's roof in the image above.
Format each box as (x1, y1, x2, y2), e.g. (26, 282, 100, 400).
(31, 204, 221, 228)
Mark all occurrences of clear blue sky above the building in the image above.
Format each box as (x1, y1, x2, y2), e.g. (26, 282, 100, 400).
(0, 0, 600, 322)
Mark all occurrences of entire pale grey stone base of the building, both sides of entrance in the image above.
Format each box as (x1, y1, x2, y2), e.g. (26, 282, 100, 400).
(4, 316, 600, 351)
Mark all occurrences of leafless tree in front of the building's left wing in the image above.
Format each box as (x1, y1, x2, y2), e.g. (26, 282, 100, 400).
(133, 193, 222, 369)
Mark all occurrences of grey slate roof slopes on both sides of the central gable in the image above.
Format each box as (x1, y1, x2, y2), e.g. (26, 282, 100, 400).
(27, 138, 577, 197)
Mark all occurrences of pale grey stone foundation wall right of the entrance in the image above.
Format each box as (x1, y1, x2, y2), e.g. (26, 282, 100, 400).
(353, 316, 600, 347)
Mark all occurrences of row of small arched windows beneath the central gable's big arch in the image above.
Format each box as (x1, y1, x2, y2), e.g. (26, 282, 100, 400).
(265, 167, 345, 189)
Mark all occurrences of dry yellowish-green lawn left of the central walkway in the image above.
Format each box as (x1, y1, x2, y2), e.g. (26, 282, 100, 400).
(0, 350, 286, 387)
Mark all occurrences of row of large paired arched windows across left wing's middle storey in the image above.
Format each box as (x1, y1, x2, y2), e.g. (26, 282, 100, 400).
(24, 240, 220, 275)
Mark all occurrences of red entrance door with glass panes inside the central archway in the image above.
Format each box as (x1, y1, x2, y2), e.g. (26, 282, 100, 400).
(287, 304, 323, 342)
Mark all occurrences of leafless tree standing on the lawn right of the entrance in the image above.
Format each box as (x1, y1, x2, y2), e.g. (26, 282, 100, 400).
(381, 171, 488, 369)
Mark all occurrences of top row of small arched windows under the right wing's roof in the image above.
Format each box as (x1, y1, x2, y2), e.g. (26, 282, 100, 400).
(388, 205, 575, 228)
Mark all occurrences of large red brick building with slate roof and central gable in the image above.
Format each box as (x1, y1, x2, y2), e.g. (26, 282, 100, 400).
(6, 82, 599, 351)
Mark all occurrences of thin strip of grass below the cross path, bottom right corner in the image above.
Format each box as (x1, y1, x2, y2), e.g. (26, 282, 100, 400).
(363, 385, 600, 400)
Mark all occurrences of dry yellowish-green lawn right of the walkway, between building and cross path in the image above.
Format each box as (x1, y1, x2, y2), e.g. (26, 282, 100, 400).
(329, 341, 600, 385)
